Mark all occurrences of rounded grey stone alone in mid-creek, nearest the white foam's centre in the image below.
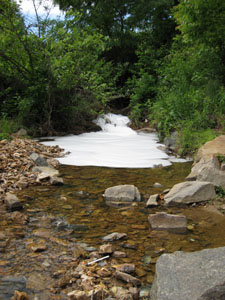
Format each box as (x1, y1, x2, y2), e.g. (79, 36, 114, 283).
(103, 184, 141, 202)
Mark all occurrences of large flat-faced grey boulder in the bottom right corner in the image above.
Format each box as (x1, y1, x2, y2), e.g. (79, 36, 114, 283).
(151, 247, 225, 300)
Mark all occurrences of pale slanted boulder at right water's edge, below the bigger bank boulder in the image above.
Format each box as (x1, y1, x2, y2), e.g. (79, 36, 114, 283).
(164, 181, 216, 206)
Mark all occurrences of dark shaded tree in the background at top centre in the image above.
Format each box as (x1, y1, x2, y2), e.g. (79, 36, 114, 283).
(55, 0, 177, 93)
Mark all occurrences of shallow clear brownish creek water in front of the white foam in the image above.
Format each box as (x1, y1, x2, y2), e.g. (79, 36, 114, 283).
(0, 162, 225, 300)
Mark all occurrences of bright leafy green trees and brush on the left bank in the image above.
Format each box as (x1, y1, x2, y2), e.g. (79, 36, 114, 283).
(0, 0, 114, 134)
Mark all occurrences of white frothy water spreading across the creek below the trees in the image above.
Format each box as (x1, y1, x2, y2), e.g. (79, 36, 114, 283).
(41, 114, 185, 168)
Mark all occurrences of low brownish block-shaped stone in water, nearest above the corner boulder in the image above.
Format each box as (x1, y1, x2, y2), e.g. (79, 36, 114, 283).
(148, 212, 187, 233)
